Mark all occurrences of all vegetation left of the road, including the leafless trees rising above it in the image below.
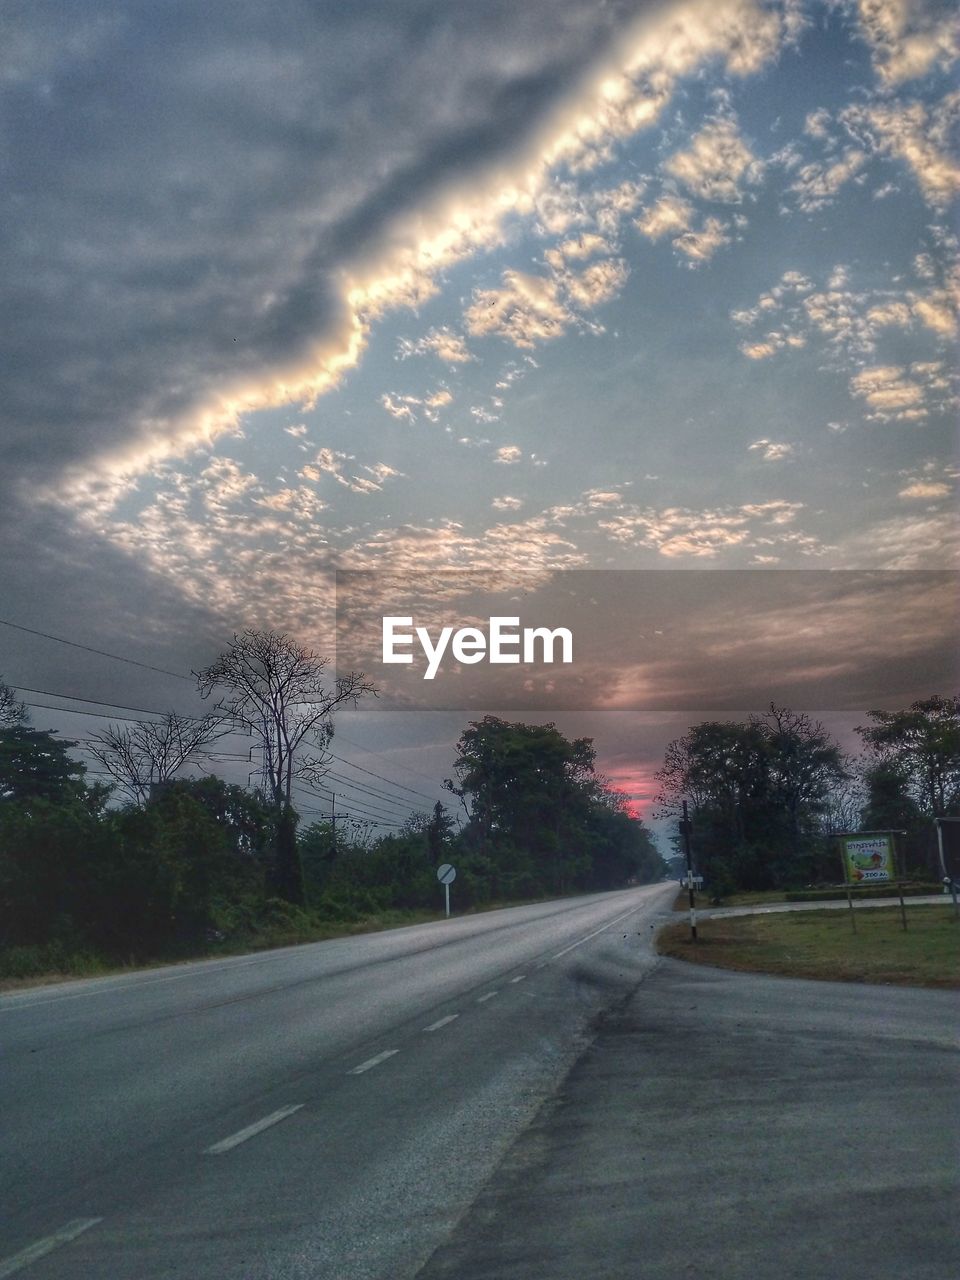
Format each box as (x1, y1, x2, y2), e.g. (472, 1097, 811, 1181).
(0, 645, 664, 982)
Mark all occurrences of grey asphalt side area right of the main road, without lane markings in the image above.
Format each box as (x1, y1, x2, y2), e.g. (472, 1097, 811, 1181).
(420, 960, 960, 1280)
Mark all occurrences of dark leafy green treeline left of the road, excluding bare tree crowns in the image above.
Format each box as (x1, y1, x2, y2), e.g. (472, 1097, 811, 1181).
(0, 685, 663, 975)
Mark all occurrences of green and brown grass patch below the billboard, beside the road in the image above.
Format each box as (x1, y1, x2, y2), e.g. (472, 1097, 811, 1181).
(657, 906, 960, 987)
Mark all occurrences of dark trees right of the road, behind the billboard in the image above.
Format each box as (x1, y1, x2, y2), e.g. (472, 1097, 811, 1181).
(658, 695, 960, 897)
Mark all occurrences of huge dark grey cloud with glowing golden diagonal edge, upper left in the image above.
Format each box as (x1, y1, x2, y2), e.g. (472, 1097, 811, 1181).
(0, 0, 800, 517)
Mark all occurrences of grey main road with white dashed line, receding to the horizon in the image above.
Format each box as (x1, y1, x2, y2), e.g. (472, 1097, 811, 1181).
(0, 883, 676, 1280)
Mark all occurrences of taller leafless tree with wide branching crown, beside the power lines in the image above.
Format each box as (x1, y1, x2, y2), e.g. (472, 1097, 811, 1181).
(195, 630, 376, 809)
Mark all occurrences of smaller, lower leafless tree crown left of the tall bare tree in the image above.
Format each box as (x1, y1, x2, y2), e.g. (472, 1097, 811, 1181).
(90, 712, 232, 808)
